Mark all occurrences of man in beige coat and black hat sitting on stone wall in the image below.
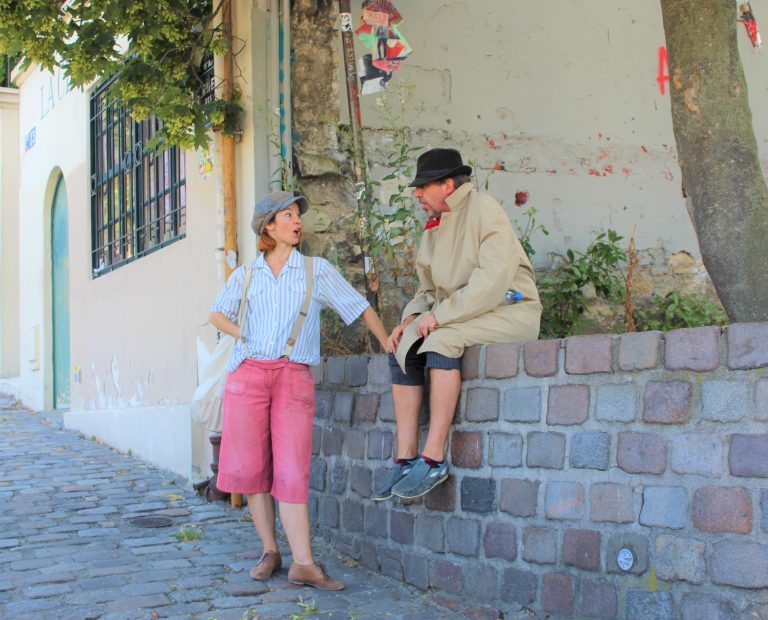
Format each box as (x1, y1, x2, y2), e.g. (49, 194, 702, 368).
(373, 148, 541, 501)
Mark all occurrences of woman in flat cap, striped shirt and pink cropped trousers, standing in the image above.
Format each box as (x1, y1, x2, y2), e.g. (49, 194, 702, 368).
(210, 192, 387, 590)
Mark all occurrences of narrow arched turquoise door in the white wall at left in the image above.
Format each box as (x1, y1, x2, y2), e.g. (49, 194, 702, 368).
(51, 177, 69, 409)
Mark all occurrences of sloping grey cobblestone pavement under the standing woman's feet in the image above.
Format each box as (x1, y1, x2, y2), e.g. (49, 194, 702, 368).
(0, 396, 468, 620)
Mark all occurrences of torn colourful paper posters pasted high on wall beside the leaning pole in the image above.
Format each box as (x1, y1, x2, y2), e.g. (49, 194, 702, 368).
(355, 0, 413, 95)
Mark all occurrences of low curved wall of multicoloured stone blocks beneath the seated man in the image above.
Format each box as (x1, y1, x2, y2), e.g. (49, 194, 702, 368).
(310, 324, 768, 620)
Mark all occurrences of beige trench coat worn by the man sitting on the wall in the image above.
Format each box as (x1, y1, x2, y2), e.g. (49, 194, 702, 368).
(396, 183, 541, 368)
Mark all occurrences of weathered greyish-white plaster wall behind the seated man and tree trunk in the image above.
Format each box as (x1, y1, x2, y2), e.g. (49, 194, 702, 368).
(340, 0, 768, 263)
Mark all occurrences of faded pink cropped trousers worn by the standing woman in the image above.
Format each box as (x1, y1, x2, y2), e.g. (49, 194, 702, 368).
(216, 358, 315, 504)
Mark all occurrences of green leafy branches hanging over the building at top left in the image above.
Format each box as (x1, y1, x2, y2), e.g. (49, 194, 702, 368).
(0, 0, 241, 148)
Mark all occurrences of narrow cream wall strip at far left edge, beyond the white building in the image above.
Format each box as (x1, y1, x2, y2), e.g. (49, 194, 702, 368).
(0, 88, 19, 377)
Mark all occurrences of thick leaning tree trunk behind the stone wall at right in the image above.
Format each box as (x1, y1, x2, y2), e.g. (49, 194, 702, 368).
(661, 0, 768, 322)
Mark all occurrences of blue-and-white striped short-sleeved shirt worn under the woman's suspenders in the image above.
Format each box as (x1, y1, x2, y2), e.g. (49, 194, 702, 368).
(211, 250, 368, 372)
